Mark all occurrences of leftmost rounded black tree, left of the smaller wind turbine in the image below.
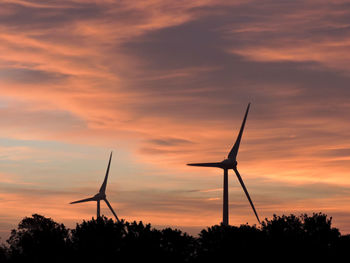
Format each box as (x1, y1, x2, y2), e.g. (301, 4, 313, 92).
(7, 214, 68, 262)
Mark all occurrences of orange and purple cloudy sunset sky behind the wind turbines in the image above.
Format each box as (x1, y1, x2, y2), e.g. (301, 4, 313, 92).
(0, 0, 350, 239)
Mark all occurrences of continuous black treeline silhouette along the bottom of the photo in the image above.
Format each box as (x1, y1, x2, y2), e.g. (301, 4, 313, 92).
(0, 213, 350, 263)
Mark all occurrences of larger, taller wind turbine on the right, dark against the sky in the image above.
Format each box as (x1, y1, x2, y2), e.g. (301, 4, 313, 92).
(187, 103, 260, 225)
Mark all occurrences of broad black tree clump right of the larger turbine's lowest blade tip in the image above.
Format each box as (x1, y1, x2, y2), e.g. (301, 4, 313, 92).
(261, 213, 340, 260)
